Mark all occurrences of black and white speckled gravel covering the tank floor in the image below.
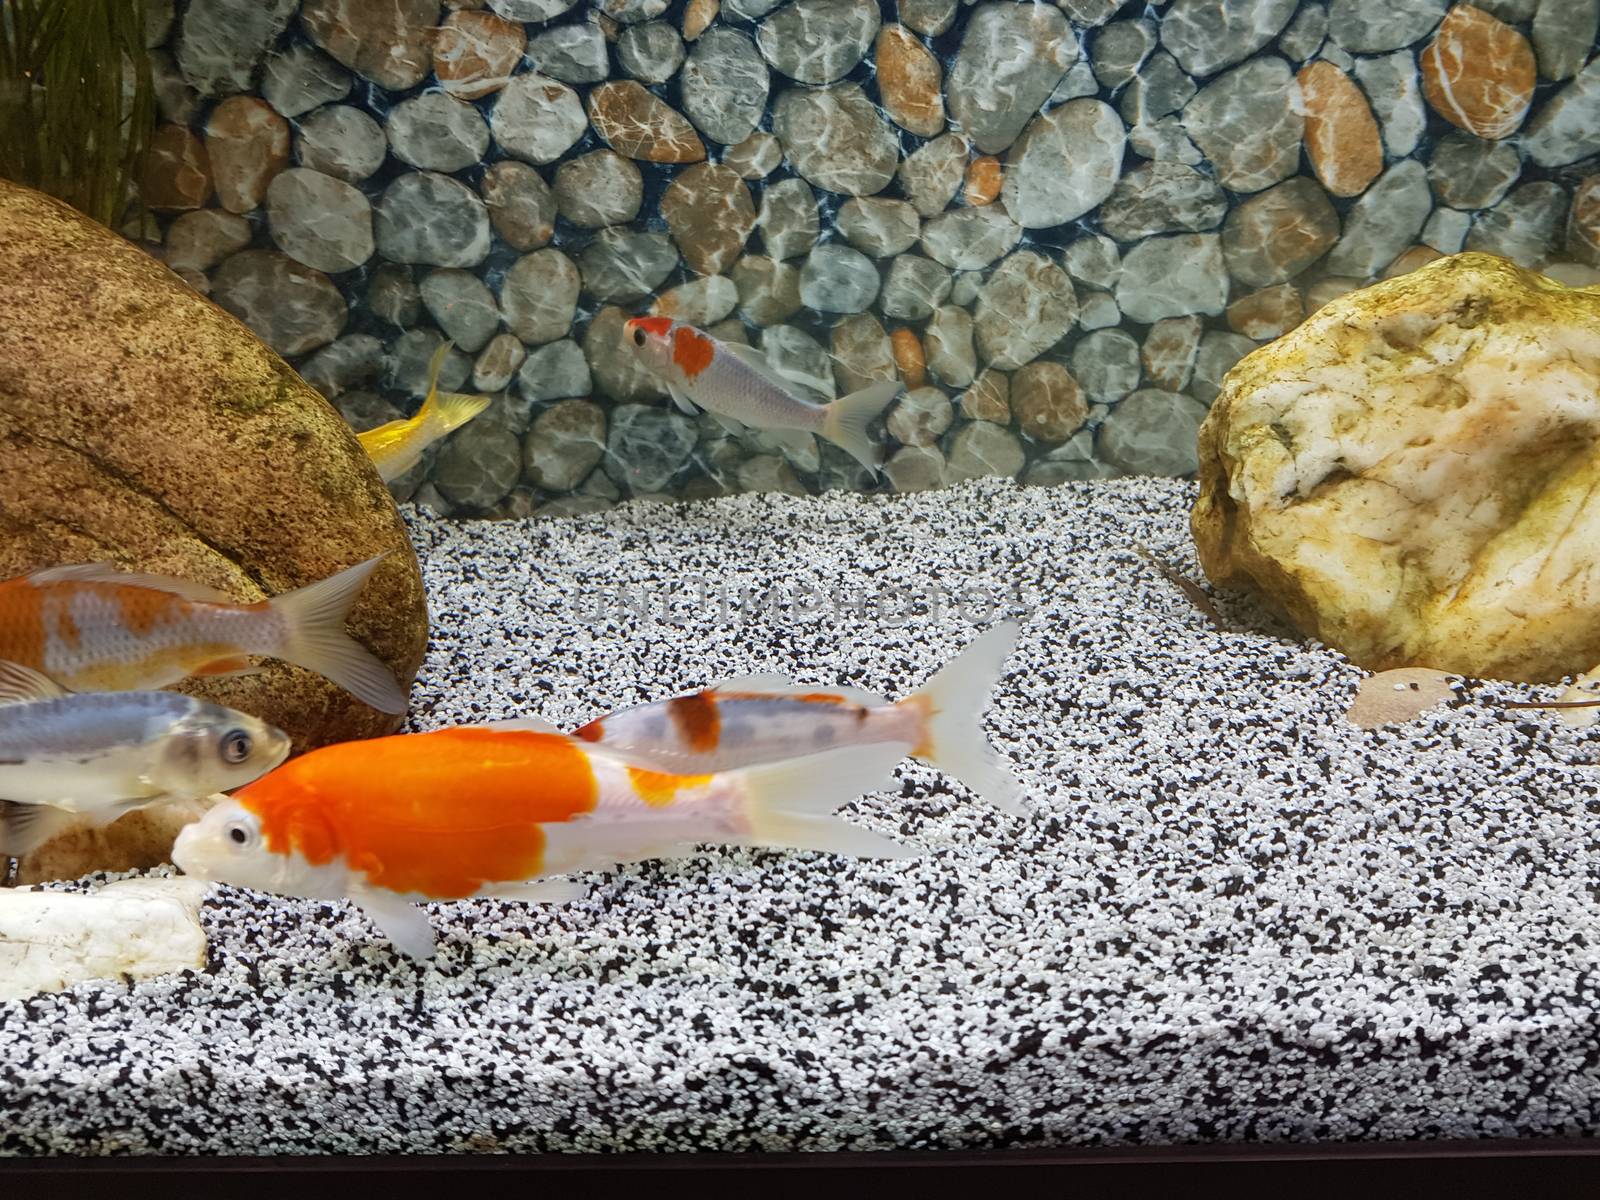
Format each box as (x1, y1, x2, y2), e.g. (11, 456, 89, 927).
(0, 478, 1600, 1154)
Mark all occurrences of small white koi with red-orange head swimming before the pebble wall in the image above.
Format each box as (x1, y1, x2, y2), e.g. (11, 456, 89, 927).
(622, 317, 901, 472)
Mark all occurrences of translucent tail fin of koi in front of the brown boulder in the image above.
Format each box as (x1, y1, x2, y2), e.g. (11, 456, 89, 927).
(270, 555, 406, 712)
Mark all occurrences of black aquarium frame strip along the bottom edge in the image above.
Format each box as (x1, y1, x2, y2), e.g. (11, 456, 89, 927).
(9, 1138, 1600, 1200)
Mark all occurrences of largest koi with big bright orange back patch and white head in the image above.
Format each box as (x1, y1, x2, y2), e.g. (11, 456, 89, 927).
(173, 722, 918, 958)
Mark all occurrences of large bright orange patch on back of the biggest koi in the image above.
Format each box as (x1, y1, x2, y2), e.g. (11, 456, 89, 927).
(235, 726, 598, 899)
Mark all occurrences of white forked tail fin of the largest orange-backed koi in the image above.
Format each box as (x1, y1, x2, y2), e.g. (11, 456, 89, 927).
(733, 742, 922, 858)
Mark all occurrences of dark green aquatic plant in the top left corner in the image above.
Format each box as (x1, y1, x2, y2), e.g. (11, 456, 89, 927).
(0, 0, 155, 226)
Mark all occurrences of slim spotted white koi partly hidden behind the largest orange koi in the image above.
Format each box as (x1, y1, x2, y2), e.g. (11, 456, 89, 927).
(573, 621, 1024, 814)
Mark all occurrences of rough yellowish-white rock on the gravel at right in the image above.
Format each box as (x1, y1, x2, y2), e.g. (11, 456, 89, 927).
(1192, 253, 1600, 682)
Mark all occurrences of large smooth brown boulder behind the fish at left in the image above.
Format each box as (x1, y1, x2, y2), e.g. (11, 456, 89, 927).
(0, 181, 427, 883)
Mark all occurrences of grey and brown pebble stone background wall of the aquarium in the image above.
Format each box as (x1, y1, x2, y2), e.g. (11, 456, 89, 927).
(130, 0, 1600, 515)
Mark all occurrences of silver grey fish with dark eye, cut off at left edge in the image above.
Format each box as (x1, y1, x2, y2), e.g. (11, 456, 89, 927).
(0, 662, 290, 859)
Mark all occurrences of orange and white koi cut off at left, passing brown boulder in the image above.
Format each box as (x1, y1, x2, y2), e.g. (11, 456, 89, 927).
(0, 555, 406, 712)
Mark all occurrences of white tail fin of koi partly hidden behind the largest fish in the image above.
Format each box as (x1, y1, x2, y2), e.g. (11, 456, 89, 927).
(901, 621, 1026, 816)
